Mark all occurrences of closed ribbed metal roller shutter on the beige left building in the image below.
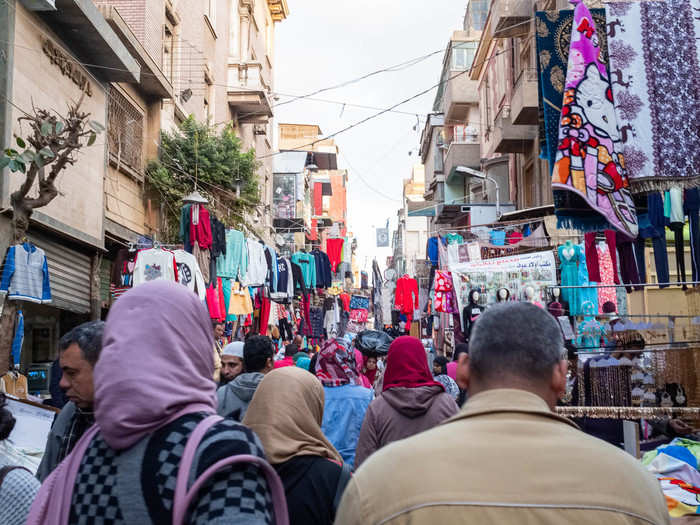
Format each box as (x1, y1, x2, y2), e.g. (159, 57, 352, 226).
(27, 233, 91, 313)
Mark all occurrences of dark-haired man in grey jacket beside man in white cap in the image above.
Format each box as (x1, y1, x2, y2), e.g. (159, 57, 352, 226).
(216, 335, 275, 421)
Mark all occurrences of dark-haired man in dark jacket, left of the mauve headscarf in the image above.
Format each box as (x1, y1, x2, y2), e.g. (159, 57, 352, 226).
(36, 321, 104, 481)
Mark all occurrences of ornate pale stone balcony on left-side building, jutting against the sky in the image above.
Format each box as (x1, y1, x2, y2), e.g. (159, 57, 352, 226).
(227, 62, 272, 124)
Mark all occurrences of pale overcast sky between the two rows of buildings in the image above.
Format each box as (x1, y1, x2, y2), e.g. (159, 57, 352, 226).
(274, 0, 467, 270)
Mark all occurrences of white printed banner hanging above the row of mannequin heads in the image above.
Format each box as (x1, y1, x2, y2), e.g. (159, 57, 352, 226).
(450, 250, 557, 324)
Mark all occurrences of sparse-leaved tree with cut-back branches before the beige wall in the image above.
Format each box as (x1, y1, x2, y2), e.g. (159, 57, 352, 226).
(0, 93, 104, 374)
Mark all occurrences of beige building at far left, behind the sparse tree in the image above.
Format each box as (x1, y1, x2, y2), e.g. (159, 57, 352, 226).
(0, 0, 142, 373)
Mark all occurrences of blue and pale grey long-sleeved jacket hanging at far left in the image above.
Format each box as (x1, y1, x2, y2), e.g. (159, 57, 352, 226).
(0, 242, 51, 304)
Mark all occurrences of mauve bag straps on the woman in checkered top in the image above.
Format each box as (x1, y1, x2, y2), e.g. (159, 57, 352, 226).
(173, 414, 289, 525)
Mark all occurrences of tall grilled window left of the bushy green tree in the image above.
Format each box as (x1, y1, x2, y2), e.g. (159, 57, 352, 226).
(107, 89, 143, 174)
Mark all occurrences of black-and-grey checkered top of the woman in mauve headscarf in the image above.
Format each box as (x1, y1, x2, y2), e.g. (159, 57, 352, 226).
(68, 413, 273, 525)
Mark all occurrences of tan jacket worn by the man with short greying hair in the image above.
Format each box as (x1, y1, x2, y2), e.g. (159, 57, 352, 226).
(336, 390, 669, 525)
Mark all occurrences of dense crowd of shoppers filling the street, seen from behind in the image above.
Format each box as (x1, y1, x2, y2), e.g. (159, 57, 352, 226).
(0, 281, 669, 525)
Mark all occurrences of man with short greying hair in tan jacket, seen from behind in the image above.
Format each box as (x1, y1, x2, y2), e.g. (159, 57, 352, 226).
(336, 303, 669, 525)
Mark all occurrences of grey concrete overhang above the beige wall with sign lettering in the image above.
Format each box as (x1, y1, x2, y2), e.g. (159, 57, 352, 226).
(38, 0, 141, 82)
